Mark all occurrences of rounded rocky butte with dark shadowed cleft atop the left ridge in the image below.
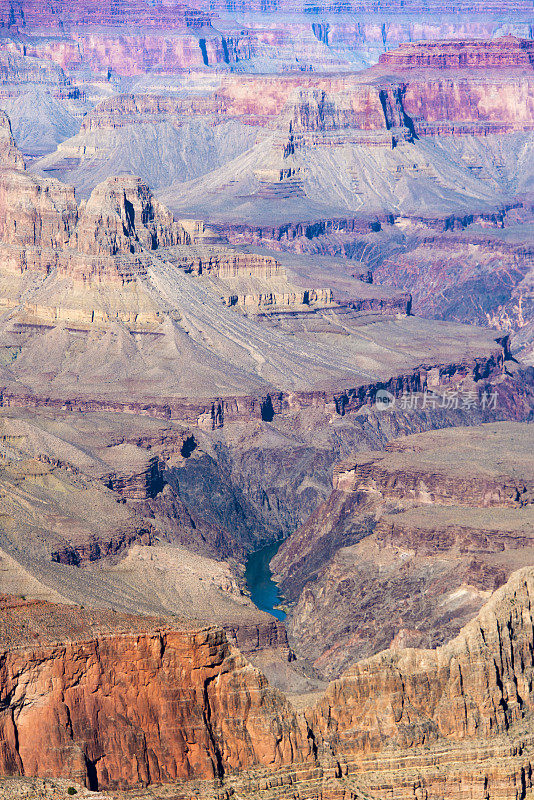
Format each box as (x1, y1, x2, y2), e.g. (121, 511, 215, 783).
(70, 175, 188, 256)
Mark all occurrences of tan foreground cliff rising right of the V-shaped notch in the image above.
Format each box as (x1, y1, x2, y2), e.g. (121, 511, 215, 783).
(308, 570, 533, 797)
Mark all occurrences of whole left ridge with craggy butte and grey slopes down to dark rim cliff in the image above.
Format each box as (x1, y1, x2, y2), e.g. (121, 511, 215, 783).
(0, 109, 516, 428)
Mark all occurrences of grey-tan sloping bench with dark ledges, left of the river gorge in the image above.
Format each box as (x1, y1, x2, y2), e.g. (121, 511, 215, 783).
(0, 410, 252, 568)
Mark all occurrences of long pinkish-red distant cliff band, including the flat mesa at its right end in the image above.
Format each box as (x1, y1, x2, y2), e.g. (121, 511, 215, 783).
(77, 44, 533, 135)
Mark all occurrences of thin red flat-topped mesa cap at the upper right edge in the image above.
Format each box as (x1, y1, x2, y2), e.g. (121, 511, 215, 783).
(378, 36, 534, 70)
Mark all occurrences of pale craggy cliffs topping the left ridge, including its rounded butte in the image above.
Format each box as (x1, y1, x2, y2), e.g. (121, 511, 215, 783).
(0, 119, 188, 304)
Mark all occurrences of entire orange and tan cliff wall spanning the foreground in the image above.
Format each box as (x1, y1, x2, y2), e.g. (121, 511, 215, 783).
(4, 569, 533, 800)
